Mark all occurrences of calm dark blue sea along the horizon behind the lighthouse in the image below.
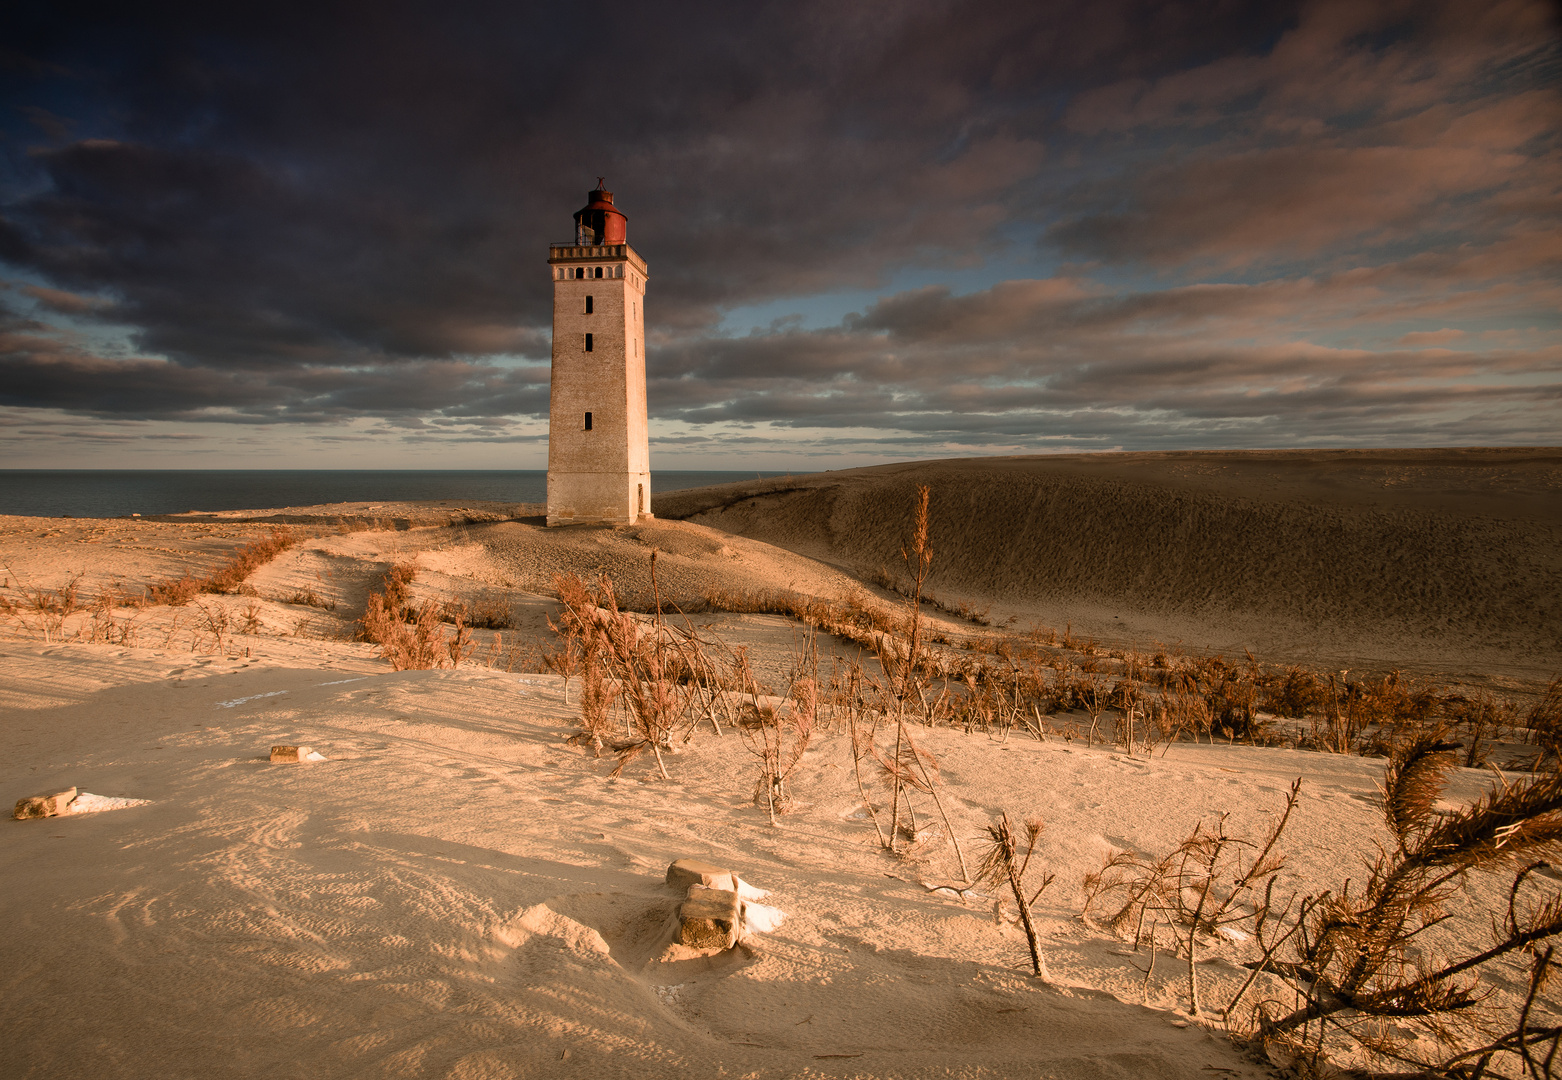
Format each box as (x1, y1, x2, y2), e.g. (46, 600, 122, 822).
(0, 469, 786, 517)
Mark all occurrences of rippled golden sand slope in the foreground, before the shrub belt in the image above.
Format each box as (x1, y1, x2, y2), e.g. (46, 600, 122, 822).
(0, 636, 1523, 1080)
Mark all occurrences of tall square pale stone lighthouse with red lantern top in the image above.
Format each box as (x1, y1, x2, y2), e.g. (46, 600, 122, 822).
(548, 177, 651, 525)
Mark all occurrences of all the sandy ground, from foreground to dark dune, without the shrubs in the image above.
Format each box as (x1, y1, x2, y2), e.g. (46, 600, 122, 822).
(0, 450, 1562, 1080)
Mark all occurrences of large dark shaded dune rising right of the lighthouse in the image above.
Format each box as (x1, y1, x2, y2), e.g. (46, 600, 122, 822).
(654, 449, 1562, 683)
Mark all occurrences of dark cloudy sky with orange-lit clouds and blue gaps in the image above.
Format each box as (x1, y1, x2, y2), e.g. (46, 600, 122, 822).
(0, 0, 1562, 470)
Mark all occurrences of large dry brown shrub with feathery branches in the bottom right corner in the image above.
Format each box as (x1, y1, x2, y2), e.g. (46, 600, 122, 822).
(1232, 738, 1562, 1080)
